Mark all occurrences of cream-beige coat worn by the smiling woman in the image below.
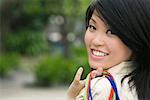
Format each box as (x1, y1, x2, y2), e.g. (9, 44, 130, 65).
(76, 62, 138, 100)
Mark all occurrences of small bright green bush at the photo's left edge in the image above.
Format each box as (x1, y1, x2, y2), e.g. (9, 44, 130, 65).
(0, 53, 20, 77)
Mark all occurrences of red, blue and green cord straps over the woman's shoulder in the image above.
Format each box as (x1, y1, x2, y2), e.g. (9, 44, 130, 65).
(84, 71, 120, 100)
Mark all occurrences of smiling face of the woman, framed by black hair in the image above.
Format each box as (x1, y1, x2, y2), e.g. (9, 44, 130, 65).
(84, 13, 132, 69)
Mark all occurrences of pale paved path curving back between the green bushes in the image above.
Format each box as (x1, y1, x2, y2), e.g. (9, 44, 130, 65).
(0, 72, 67, 100)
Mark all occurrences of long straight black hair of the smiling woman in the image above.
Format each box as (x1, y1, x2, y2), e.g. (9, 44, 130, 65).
(86, 0, 150, 100)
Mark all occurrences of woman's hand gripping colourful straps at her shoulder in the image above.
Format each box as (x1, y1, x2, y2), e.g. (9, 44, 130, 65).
(67, 67, 103, 100)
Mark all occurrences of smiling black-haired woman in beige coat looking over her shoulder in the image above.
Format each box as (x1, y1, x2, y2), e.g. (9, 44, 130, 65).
(68, 0, 150, 100)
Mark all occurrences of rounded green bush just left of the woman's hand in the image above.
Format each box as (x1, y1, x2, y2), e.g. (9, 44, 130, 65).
(35, 54, 73, 86)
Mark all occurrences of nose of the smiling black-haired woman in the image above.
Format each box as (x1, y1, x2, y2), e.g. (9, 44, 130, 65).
(92, 35, 105, 46)
